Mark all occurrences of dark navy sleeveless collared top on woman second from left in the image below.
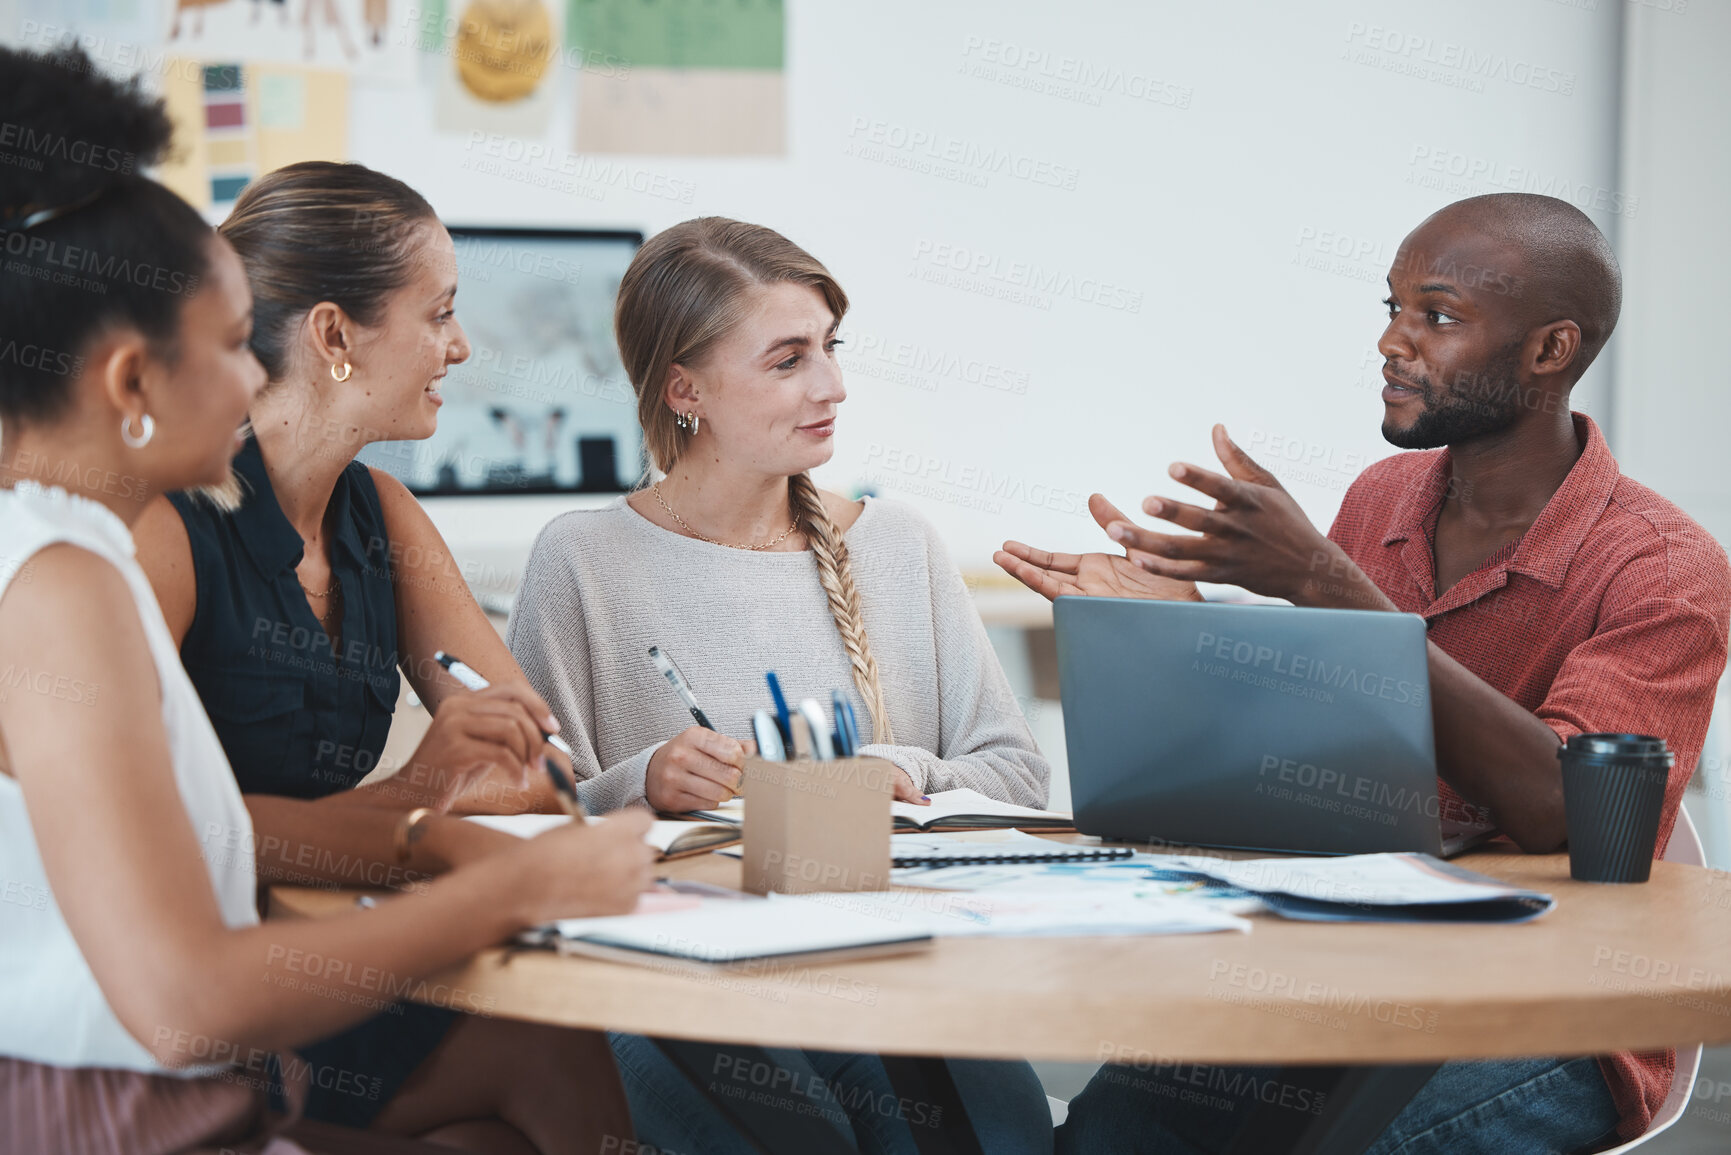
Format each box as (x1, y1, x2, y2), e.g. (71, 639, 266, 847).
(170, 440, 400, 798)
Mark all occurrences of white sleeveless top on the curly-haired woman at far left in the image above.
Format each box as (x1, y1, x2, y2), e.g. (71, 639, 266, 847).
(0, 481, 258, 1077)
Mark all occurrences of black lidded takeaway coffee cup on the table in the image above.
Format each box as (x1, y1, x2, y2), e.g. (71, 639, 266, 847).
(1556, 734, 1676, 883)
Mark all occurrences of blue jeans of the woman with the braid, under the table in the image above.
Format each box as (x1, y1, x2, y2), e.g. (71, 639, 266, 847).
(608, 1034, 1052, 1155)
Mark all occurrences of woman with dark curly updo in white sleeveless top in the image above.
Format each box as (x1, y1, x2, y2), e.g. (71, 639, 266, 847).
(0, 48, 653, 1155)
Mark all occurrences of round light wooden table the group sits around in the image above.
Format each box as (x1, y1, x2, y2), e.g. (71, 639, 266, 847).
(272, 854, 1731, 1063)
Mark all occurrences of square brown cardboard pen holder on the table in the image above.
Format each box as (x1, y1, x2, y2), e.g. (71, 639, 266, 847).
(744, 757, 895, 894)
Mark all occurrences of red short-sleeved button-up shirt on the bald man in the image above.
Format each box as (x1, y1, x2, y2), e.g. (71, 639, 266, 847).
(1328, 414, 1731, 1141)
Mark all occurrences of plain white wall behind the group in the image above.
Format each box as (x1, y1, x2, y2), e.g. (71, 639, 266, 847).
(330, 0, 1620, 568)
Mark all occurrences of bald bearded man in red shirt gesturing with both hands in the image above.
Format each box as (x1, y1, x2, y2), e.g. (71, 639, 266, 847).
(997, 194, 1731, 1155)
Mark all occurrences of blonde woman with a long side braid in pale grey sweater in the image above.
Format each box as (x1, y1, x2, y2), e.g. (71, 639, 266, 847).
(507, 216, 1052, 1152)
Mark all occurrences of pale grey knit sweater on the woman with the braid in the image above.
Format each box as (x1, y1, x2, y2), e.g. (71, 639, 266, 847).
(505, 499, 1051, 814)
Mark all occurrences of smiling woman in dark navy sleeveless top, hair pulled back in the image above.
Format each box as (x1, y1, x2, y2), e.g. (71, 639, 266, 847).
(135, 163, 628, 1150)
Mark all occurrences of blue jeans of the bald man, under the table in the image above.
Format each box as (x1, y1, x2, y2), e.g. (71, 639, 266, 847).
(1058, 1058, 1618, 1155)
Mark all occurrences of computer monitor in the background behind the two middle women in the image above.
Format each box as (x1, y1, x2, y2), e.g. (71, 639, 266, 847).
(360, 225, 644, 497)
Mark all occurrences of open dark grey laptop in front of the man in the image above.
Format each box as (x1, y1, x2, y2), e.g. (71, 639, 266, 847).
(1054, 597, 1492, 857)
